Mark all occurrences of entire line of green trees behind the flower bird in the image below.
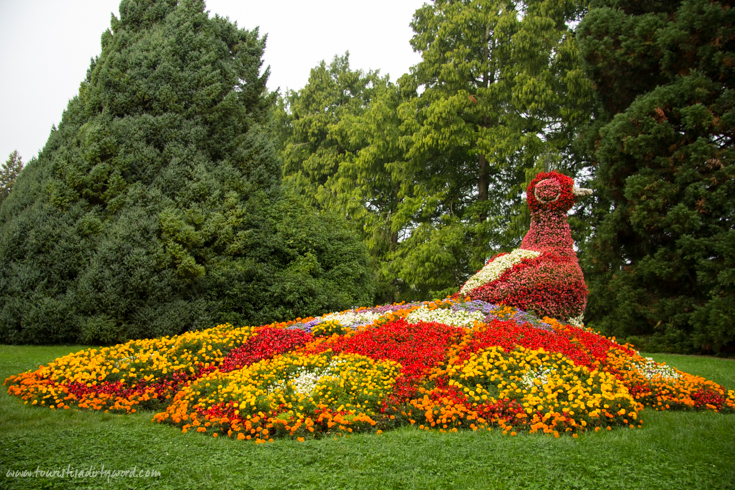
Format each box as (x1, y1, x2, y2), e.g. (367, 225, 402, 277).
(0, 0, 735, 354)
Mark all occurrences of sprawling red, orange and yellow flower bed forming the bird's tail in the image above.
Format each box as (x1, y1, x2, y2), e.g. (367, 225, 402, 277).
(5, 298, 735, 442)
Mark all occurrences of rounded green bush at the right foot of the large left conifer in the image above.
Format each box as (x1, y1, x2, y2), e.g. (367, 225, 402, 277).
(208, 189, 374, 330)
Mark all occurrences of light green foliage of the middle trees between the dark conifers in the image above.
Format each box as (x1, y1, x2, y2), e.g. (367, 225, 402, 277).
(278, 0, 591, 302)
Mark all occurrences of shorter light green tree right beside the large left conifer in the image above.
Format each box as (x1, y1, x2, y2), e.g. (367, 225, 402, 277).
(276, 53, 410, 303)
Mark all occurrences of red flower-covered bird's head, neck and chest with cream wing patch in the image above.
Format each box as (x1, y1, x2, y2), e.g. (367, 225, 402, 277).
(459, 172, 592, 323)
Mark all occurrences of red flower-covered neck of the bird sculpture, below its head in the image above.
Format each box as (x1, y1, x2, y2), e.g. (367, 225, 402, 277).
(521, 210, 577, 258)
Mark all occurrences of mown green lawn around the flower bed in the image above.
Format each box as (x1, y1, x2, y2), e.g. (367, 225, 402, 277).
(0, 346, 735, 489)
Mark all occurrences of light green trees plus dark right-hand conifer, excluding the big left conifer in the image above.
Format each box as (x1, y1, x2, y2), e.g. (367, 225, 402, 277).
(276, 0, 735, 353)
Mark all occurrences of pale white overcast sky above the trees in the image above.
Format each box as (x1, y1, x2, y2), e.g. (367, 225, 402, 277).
(0, 0, 428, 163)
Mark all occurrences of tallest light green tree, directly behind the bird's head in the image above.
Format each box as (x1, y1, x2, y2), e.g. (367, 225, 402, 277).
(409, 0, 591, 245)
